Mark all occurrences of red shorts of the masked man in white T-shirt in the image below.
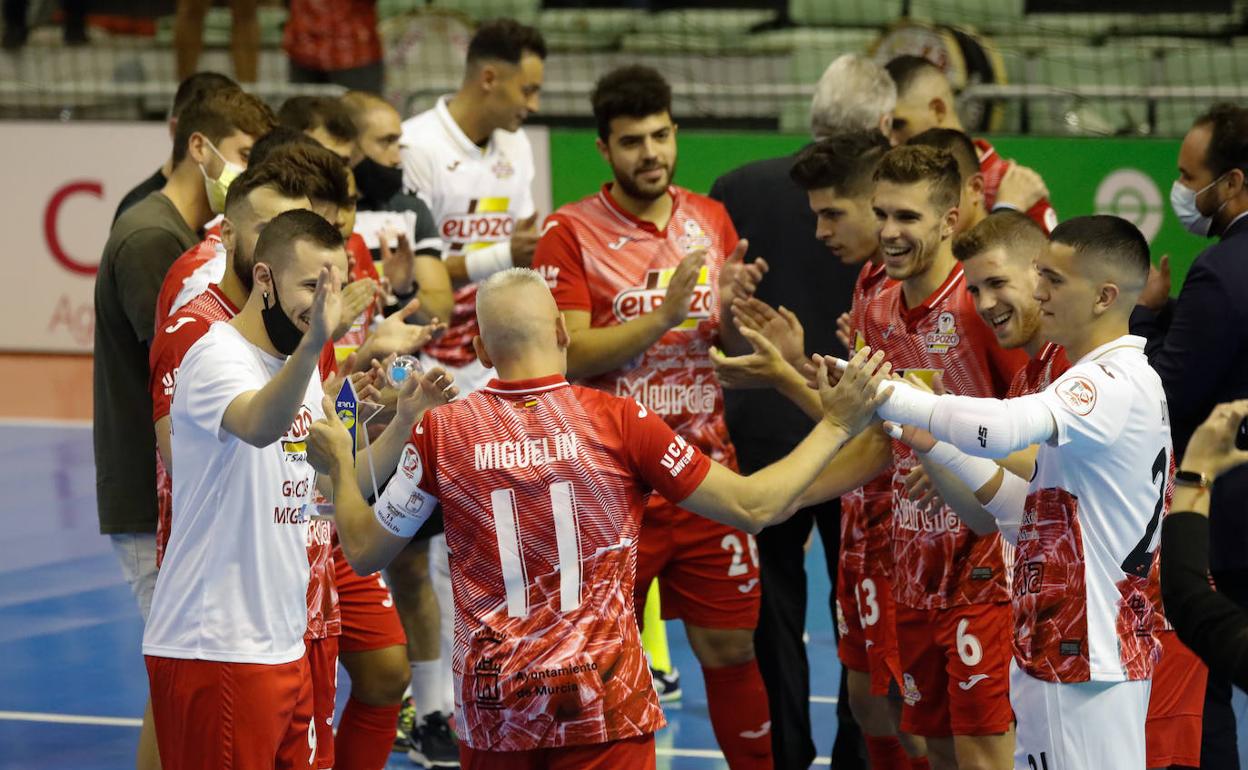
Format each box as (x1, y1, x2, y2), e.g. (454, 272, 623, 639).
(145, 655, 312, 770)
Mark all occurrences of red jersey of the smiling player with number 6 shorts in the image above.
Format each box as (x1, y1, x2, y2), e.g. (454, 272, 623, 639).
(862, 265, 1027, 609)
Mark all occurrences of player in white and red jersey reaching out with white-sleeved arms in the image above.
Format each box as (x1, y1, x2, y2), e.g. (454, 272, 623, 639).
(879, 216, 1174, 770)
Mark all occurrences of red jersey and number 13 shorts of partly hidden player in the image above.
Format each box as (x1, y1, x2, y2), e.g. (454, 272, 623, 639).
(836, 262, 901, 695)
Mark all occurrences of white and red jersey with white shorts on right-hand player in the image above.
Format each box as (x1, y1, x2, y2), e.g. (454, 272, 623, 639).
(1007, 336, 1174, 766)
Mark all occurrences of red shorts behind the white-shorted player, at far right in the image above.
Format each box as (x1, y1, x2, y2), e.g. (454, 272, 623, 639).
(1144, 630, 1209, 768)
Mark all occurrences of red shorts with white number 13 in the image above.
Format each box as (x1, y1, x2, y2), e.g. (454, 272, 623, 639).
(836, 569, 901, 695)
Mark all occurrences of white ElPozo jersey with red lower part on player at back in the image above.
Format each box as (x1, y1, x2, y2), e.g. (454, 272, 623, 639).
(402, 96, 535, 379)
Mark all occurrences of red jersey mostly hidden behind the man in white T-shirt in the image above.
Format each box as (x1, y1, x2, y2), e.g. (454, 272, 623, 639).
(147, 285, 342, 639)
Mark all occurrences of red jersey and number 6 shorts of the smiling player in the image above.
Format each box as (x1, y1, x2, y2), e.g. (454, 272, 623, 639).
(862, 265, 1027, 736)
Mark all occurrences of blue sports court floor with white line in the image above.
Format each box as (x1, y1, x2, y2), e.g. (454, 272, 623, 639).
(0, 421, 840, 770)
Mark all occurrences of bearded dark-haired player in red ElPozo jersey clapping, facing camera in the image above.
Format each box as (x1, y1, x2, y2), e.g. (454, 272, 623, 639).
(534, 66, 773, 769)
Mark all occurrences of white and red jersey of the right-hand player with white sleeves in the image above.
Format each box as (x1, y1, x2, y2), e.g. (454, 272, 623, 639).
(1012, 336, 1173, 683)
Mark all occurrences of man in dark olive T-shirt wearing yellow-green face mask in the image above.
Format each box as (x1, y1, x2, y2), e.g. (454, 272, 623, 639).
(94, 89, 273, 766)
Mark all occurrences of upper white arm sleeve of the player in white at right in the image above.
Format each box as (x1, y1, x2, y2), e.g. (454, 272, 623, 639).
(877, 381, 1057, 458)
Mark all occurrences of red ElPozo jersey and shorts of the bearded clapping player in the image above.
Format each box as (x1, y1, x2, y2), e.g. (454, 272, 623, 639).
(533, 185, 760, 628)
